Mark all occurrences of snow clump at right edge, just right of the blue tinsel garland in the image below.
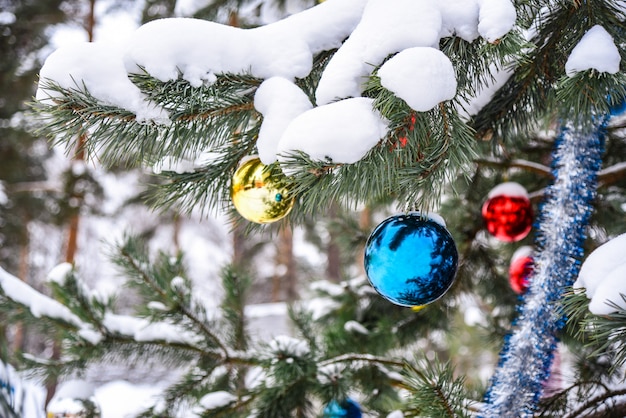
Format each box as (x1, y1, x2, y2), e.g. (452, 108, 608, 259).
(574, 234, 626, 315)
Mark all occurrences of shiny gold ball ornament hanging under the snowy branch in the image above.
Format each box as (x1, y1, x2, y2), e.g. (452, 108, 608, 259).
(230, 158, 294, 224)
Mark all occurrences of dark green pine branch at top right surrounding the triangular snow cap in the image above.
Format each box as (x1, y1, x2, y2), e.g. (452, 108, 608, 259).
(473, 1, 624, 140)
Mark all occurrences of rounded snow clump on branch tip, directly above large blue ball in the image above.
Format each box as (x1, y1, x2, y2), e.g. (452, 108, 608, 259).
(378, 47, 457, 112)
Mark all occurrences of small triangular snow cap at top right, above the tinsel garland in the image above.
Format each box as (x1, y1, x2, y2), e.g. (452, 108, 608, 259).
(565, 25, 621, 77)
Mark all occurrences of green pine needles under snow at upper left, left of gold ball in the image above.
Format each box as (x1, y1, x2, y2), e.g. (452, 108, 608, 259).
(31, 74, 260, 170)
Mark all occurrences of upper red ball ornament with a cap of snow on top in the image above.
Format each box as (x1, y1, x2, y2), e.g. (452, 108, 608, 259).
(482, 182, 533, 242)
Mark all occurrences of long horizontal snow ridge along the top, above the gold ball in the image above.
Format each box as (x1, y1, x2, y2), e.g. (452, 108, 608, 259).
(125, 0, 364, 86)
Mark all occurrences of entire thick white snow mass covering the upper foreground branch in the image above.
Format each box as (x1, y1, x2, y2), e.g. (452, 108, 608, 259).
(37, 0, 515, 169)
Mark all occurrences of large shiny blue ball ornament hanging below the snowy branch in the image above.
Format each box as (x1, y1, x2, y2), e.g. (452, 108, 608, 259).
(365, 212, 459, 307)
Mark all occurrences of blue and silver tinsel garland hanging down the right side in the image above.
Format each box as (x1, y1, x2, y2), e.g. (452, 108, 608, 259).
(481, 117, 608, 418)
